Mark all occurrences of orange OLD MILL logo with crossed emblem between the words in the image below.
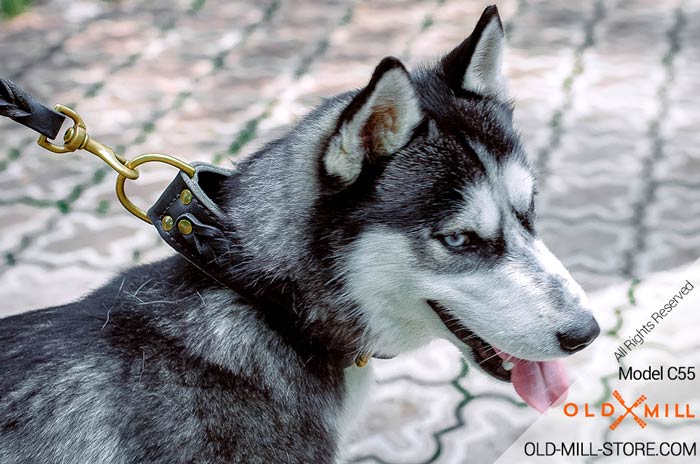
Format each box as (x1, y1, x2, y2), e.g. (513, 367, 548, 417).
(564, 390, 695, 430)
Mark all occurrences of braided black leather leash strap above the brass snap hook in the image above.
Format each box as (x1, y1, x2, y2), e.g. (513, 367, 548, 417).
(0, 77, 66, 139)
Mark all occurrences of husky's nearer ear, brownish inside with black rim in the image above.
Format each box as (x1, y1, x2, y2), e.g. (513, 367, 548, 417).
(323, 57, 423, 185)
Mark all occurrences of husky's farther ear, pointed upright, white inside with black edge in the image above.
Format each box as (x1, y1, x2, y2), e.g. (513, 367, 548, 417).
(441, 5, 507, 100)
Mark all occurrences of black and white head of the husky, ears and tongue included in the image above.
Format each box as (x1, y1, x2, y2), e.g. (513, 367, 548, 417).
(317, 7, 599, 409)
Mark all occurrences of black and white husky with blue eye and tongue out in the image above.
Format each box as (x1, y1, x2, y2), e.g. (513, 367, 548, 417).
(0, 7, 599, 464)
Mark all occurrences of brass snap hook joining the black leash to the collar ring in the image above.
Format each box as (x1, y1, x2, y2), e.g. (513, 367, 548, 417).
(36, 105, 139, 180)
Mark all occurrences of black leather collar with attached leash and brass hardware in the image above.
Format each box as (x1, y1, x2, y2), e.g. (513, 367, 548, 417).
(0, 78, 370, 367)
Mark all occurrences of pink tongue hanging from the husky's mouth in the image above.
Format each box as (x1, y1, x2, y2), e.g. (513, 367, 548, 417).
(498, 351, 569, 412)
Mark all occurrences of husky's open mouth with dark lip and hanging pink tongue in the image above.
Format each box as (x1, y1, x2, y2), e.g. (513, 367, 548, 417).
(428, 300, 569, 412)
